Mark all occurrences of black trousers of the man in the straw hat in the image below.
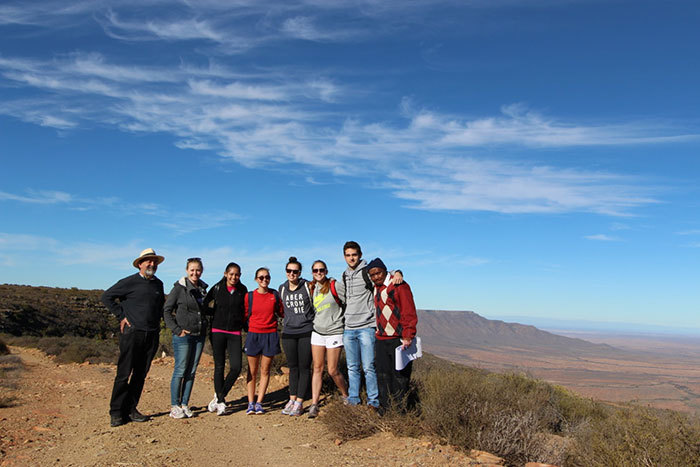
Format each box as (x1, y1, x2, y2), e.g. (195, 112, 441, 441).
(109, 326, 159, 415)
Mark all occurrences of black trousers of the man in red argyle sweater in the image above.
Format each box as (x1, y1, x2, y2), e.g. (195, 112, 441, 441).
(374, 338, 413, 409)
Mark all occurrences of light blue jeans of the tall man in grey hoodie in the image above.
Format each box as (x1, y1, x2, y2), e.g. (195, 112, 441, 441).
(343, 328, 379, 407)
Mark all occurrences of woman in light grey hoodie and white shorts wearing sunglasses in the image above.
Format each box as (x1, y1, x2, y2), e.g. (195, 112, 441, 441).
(309, 260, 348, 418)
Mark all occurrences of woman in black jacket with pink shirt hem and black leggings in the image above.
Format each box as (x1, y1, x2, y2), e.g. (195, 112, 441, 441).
(204, 263, 248, 415)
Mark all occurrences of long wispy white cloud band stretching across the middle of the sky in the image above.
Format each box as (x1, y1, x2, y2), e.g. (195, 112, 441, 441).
(0, 49, 676, 215)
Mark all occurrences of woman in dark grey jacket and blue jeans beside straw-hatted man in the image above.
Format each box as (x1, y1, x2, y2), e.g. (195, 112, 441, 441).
(163, 258, 207, 418)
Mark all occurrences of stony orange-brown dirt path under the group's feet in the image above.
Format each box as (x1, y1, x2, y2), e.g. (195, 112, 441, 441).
(0, 347, 487, 466)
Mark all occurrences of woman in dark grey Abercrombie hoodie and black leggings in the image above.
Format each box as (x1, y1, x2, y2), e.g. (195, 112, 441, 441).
(278, 256, 314, 416)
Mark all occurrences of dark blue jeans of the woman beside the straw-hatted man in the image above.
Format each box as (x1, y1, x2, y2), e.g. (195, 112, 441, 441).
(170, 334, 204, 405)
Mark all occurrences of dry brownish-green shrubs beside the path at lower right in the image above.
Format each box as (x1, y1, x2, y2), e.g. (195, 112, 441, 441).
(322, 356, 700, 467)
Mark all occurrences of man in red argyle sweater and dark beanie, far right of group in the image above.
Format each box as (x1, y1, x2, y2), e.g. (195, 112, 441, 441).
(367, 258, 418, 411)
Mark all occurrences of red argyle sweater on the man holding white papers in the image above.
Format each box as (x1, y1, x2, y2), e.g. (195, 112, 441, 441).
(374, 282, 418, 340)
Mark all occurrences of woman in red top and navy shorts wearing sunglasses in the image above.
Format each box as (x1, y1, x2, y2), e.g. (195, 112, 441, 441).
(245, 268, 284, 415)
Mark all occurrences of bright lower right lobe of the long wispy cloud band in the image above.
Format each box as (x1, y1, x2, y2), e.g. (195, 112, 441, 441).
(382, 156, 656, 216)
